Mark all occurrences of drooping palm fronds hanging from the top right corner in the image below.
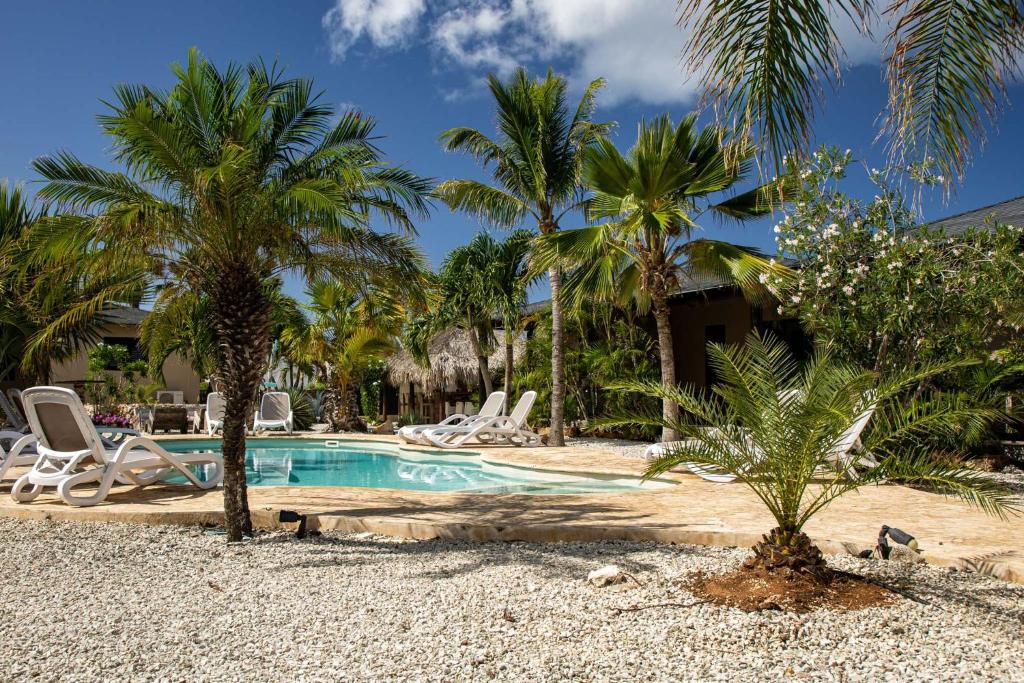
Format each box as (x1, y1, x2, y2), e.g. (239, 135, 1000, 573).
(679, 0, 1024, 183)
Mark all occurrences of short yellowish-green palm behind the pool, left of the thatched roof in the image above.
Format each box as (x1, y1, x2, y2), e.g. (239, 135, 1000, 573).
(281, 280, 404, 431)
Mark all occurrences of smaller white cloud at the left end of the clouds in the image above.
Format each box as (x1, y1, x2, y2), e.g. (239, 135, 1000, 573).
(322, 0, 426, 60)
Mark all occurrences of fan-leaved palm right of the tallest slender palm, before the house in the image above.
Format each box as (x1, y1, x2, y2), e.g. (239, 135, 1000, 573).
(535, 114, 784, 441)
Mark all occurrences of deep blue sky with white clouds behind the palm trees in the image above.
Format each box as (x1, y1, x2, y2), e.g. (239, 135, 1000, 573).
(0, 0, 1024, 298)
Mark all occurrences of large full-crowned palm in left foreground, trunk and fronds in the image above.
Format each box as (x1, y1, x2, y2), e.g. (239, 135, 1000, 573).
(35, 50, 430, 541)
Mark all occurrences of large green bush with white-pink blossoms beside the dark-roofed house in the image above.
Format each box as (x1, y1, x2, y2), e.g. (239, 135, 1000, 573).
(768, 148, 1024, 370)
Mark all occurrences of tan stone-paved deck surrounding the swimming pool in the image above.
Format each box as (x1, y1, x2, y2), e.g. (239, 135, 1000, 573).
(0, 434, 1024, 584)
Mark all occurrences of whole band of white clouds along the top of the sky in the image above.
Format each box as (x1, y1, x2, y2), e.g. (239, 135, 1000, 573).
(324, 0, 879, 104)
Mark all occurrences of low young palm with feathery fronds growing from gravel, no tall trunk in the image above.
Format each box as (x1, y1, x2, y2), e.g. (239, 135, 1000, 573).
(608, 332, 1014, 582)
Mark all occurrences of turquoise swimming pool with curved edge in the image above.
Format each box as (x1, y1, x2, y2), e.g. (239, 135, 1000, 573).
(160, 438, 664, 494)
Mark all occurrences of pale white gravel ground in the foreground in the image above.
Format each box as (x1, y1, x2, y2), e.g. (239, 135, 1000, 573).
(0, 519, 1024, 681)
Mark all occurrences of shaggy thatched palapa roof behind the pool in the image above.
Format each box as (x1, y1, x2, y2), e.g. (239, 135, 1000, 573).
(387, 328, 525, 391)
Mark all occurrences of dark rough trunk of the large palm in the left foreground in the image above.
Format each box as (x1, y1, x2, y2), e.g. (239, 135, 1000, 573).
(211, 266, 270, 542)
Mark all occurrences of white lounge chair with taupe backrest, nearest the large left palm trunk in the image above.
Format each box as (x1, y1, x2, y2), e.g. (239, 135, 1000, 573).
(11, 386, 224, 506)
